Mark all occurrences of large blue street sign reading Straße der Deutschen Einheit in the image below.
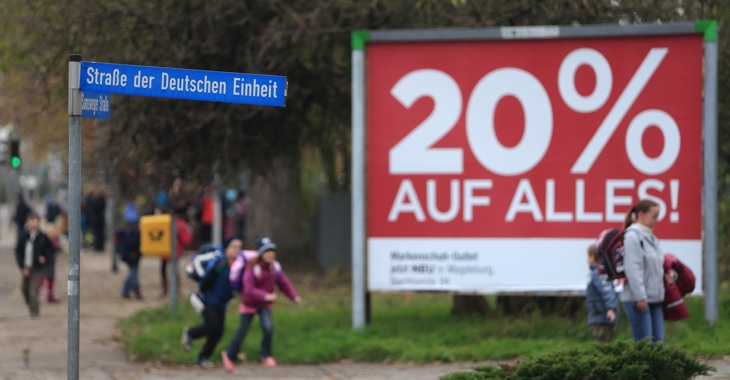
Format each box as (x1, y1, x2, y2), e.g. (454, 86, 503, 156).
(81, 62, 287, 107)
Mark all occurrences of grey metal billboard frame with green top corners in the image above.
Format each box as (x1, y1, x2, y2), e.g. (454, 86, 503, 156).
(351, 20, 718, 329)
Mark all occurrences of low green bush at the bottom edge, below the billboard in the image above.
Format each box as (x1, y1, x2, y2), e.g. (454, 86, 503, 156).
(441, 341, 715, 380)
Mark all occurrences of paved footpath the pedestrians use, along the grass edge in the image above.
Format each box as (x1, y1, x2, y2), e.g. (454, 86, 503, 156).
(0, 223, 730, 380)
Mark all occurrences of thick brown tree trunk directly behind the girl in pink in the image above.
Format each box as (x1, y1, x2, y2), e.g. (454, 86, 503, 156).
(245, 158, 304, 252)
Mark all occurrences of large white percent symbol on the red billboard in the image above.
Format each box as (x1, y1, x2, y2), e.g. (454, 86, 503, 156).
(558, 48, 680, 175)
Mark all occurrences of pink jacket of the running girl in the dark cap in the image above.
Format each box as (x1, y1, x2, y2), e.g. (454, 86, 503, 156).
(238, 262, 298, 314)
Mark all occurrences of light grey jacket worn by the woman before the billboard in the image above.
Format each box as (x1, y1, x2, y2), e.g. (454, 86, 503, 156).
(621, 224, 664, 303)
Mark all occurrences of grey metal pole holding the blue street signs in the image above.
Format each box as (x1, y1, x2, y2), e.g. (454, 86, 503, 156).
(67, 54, 81, 380)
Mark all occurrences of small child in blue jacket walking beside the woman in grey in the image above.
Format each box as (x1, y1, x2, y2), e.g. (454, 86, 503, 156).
(586, 244, 618, 343)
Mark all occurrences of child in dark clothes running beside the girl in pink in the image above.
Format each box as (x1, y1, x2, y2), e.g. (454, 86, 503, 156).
(180, 238, 242, 368)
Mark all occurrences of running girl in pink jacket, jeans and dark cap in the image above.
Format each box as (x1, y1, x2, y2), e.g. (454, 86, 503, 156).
(221, 237, 301, 372)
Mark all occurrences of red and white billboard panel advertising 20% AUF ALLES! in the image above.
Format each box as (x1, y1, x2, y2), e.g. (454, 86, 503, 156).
(365, 35, 703, 292)
